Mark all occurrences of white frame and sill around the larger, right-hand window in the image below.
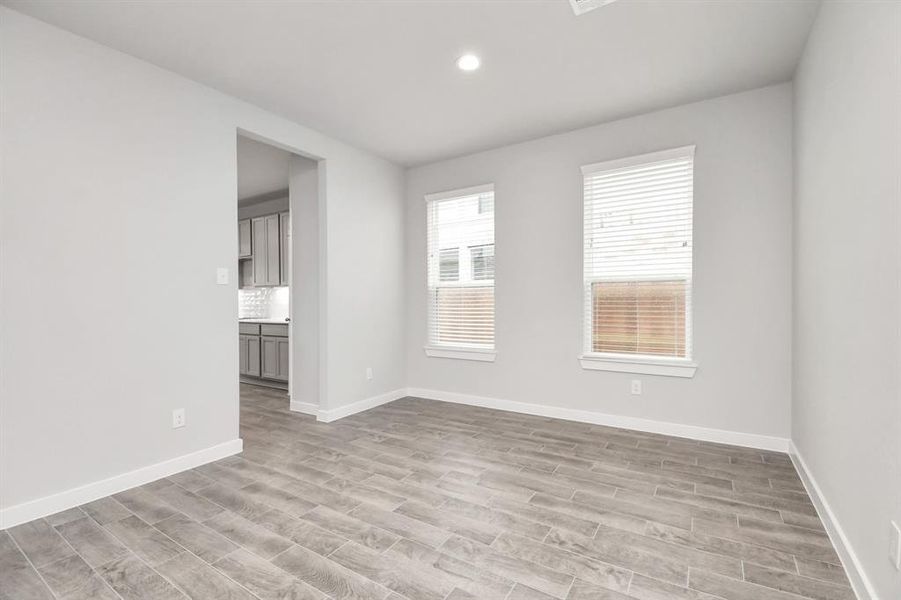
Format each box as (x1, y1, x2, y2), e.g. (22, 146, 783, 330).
(579, 145, 698, 378)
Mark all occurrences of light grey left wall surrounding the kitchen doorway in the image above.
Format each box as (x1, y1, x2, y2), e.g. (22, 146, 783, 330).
(0, 8, 404, 509)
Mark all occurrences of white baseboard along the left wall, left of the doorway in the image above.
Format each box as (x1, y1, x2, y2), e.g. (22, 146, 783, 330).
(0, 438, 244, 529)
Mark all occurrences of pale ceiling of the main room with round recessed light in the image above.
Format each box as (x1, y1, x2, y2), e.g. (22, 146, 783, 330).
(3, 0, 818, 165)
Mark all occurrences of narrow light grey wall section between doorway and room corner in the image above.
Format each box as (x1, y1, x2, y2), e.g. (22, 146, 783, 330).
(320, 152, 406, 410)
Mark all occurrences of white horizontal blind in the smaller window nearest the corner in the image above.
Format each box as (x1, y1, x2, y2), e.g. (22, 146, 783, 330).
(426, 185, 494, 350)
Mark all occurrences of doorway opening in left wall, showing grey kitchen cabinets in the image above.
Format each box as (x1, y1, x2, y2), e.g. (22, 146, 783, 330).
(237, 133, 319, 428)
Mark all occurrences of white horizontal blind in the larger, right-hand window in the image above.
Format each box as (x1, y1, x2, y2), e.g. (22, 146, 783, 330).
(582, 146, 694, 360)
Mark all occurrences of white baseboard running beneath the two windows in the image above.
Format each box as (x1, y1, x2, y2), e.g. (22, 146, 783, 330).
(407, 388, 789, 452)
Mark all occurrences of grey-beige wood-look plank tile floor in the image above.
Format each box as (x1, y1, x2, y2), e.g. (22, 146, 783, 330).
(0, 386, 854, 600)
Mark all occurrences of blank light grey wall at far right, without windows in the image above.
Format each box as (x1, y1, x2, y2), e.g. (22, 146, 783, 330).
(792, 2, 901, 600)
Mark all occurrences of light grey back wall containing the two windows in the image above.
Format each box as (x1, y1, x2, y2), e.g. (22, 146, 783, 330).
(407, 85, 792, 438)
